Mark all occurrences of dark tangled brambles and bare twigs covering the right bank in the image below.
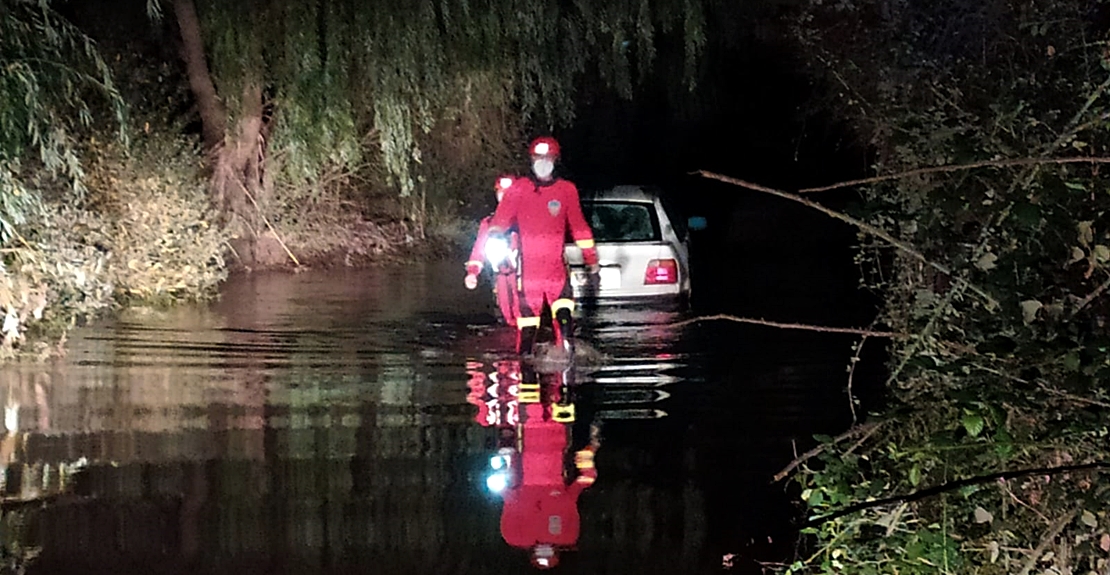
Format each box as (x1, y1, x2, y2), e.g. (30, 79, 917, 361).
(780, 0, 1110, 575)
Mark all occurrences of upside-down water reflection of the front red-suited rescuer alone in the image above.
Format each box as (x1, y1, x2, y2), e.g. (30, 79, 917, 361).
(501, 374, 601, 568)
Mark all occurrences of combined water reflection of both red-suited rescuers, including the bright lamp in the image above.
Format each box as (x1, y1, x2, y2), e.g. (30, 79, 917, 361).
(471, 362, 601, 568)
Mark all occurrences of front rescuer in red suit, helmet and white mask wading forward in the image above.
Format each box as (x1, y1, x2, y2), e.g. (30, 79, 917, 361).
(490, 137, 598, 354)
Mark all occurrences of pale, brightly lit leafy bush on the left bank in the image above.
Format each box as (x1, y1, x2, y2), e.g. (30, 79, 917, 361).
(0, 133, 226, 353)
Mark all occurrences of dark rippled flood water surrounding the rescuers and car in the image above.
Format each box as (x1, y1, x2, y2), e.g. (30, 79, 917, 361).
(0, 239, 883, 575)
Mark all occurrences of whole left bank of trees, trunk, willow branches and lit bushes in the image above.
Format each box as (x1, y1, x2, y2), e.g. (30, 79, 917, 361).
(0, 0, 705, 356)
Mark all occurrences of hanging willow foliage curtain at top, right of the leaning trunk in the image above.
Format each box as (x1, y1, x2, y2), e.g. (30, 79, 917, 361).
(159, 0, 705, 207)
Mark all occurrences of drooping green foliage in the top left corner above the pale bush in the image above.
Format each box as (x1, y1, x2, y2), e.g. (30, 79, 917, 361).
(0, 0, 124, 245)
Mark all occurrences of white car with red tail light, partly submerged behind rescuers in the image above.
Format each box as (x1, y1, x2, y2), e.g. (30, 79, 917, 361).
(564, 185, 705, 300)
